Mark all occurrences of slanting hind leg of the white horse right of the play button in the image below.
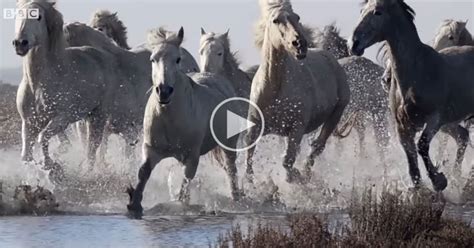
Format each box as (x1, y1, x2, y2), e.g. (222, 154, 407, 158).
(305, 104, 346, 179)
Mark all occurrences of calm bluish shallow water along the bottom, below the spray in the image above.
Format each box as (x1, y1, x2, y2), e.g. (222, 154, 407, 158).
(0, 206, 474, 248)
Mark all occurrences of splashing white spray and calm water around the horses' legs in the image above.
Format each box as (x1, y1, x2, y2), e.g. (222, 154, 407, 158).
(0, 132, 474, 248)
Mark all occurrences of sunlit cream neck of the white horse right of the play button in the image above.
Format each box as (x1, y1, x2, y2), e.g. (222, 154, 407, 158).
(259, 29, 288, 99)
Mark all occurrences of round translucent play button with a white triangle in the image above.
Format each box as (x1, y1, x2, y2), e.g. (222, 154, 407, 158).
(210, 97, 265, 152)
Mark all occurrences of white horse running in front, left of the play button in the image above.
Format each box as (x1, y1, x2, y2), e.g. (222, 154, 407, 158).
(127, 28, 243, 217)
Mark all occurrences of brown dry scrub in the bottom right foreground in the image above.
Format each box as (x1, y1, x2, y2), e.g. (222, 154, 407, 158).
(217, 190, 474, 248)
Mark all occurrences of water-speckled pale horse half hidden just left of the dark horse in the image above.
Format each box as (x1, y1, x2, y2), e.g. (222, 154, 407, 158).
(315, 24, 390, 170)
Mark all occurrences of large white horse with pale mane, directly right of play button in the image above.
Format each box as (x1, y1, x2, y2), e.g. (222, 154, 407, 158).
(246, 0, 350, 182)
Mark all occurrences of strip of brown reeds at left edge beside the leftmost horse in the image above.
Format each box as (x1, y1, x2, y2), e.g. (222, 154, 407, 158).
(0, 81, 21, 149)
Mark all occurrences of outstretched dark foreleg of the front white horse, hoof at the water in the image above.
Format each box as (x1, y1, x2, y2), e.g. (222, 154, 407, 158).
(127, 144, 163, 218)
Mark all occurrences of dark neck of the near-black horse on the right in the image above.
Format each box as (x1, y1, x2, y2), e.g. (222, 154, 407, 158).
(385, 13, 426, 88)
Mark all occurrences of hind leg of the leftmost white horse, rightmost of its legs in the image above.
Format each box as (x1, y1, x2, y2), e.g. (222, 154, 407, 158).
(87, 113, 106, 166)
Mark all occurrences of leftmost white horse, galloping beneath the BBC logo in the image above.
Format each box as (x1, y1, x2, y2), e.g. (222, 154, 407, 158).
(13, 0, 119, 176)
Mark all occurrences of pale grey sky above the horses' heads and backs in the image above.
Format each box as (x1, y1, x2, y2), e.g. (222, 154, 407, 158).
(0, 0, 474, 70)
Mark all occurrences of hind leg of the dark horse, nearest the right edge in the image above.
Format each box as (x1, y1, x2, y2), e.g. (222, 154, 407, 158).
(442, 125, 469, 178)
